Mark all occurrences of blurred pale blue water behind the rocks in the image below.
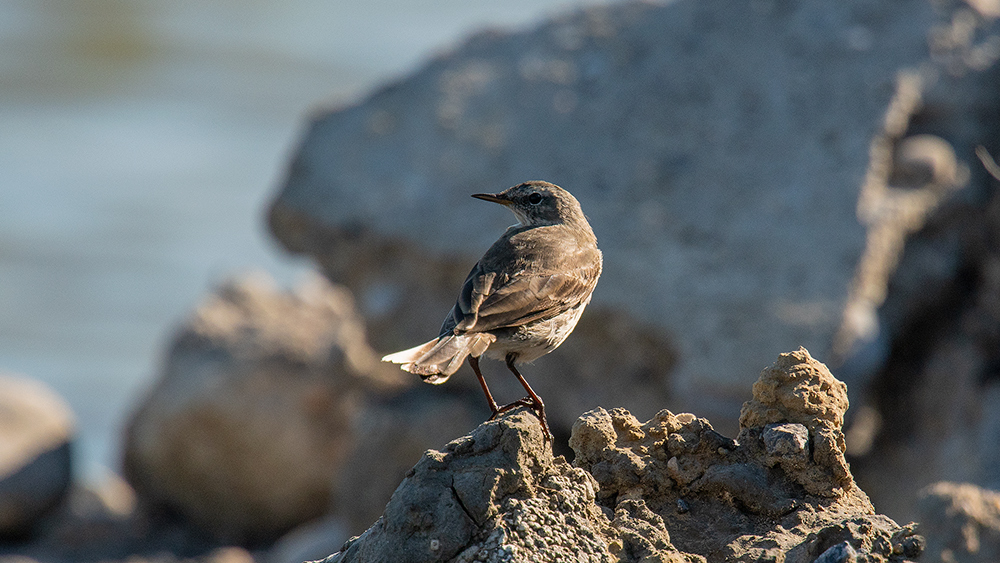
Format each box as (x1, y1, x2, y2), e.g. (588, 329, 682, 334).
(0, 0, 616, 479)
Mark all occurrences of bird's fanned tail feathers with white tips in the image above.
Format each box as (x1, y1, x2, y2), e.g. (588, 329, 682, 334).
(382, 332, 496, 385)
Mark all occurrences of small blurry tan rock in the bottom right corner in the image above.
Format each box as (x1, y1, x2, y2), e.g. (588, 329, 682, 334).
(918, 482, 1000, 563)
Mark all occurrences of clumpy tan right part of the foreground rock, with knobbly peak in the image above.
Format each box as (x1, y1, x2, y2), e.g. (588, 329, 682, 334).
(571, 349, 915, 562)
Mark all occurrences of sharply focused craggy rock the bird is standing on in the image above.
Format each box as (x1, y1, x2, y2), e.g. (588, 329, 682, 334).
(314, 349, 922, 563)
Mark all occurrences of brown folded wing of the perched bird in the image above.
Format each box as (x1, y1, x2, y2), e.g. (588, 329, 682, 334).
(456, 261, 601, 338)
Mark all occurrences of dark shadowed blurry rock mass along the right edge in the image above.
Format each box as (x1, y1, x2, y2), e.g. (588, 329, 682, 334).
(837, 6, 1000, 520)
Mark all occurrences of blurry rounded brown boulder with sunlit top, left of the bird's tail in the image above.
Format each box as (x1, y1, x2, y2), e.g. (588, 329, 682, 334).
(125, 278, 403, 543)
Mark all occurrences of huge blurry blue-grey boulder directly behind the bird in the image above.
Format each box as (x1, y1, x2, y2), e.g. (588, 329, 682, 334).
(270, 0, 995, 431)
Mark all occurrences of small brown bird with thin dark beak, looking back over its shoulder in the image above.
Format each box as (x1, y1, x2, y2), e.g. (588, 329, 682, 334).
(382, 181, 603, 441)
